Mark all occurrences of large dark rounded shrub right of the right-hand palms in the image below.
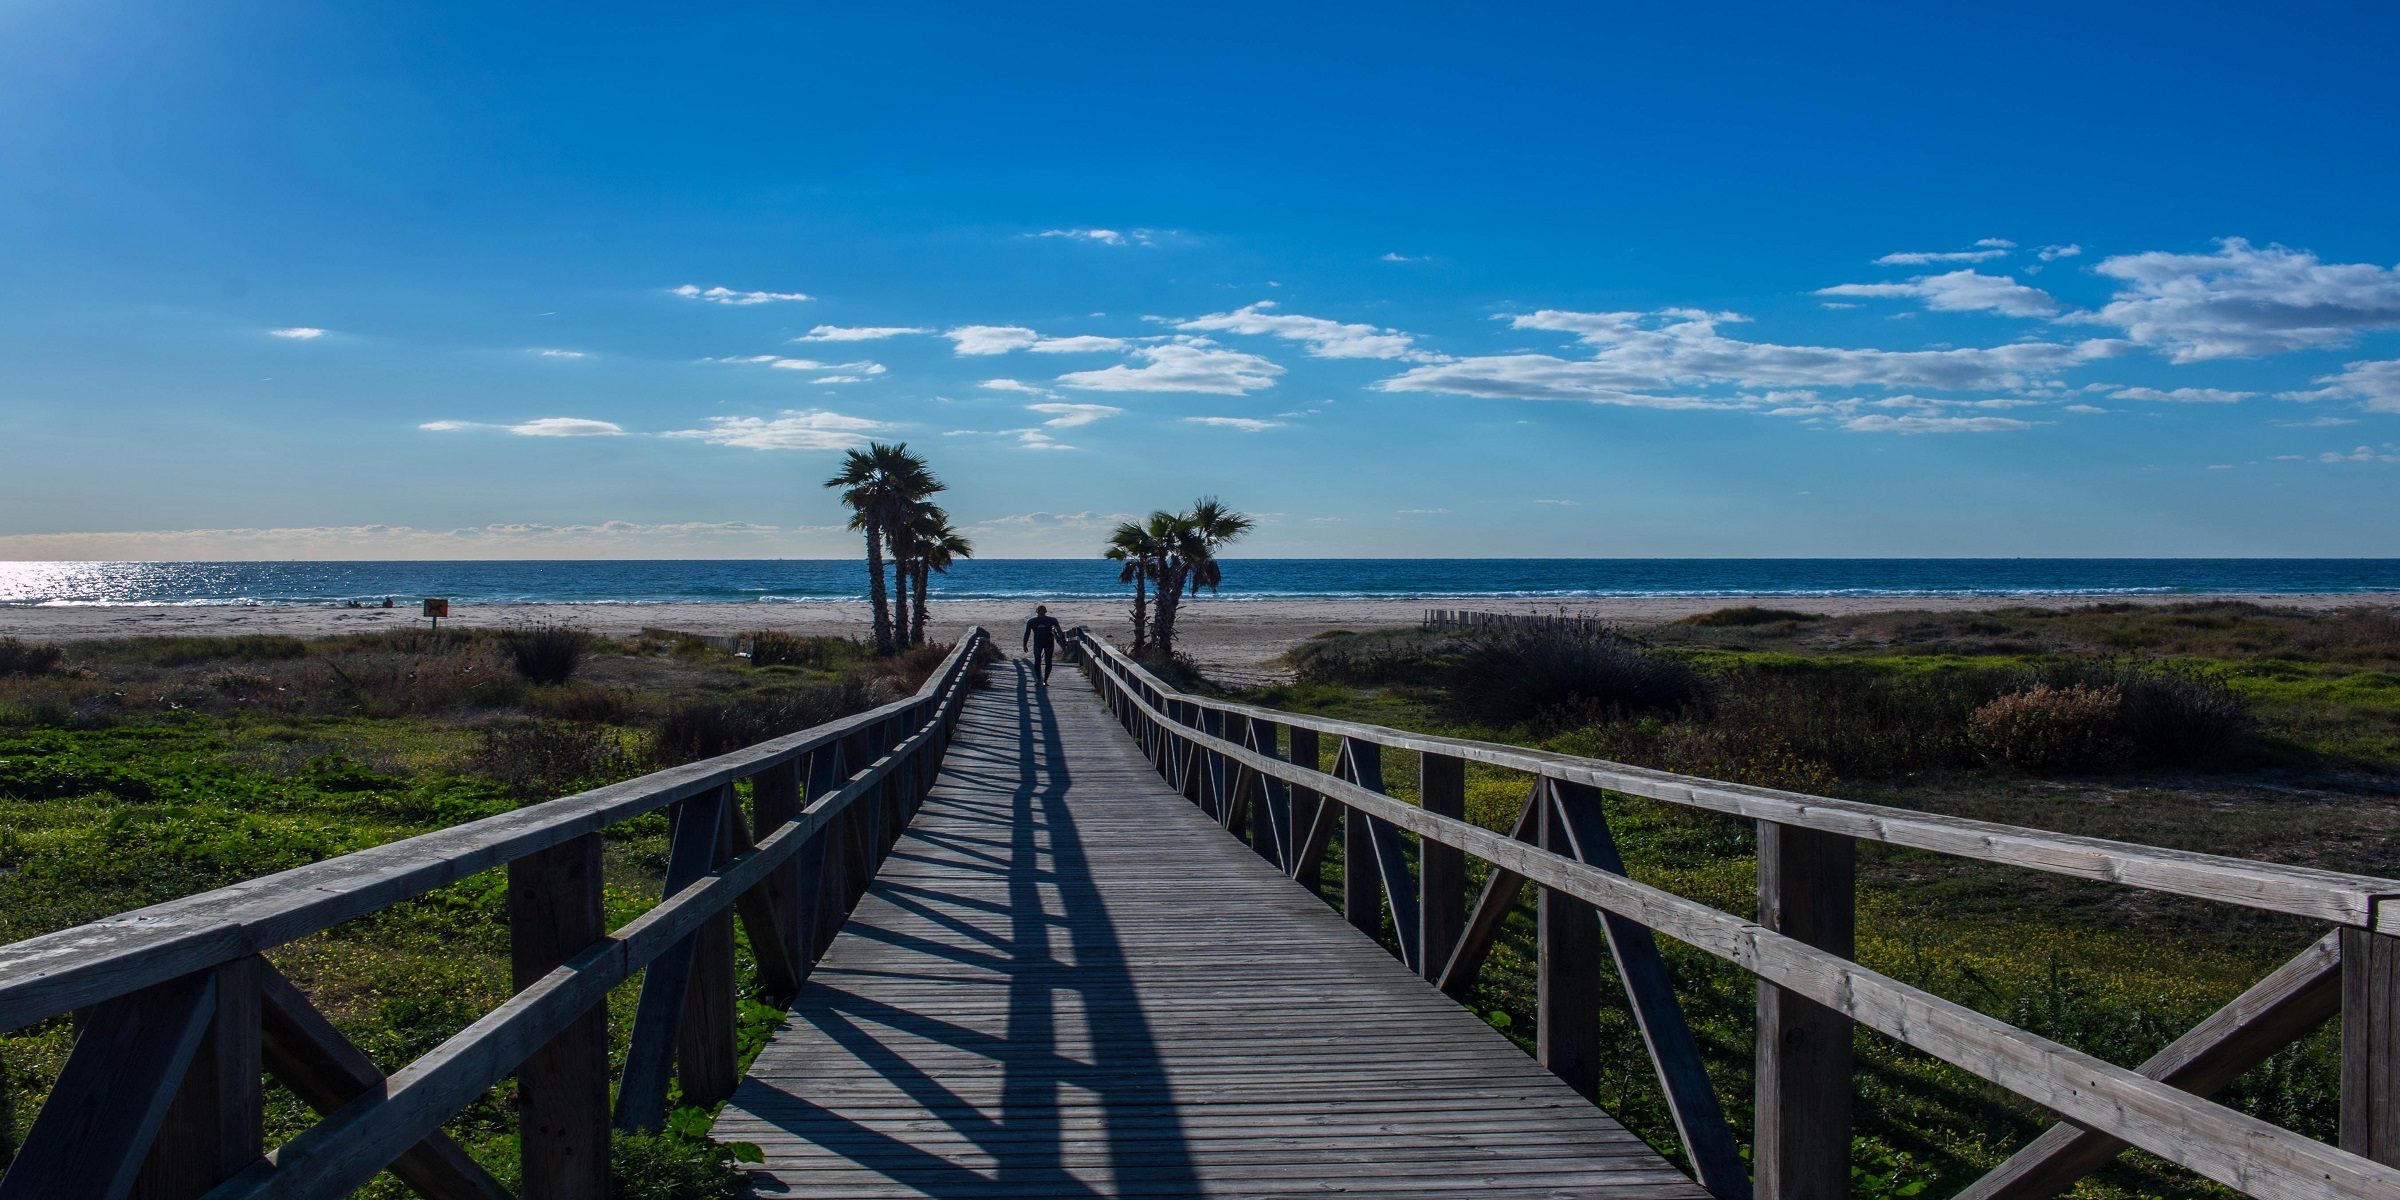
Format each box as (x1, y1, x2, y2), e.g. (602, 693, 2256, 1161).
(1440, 626, 1706, 725)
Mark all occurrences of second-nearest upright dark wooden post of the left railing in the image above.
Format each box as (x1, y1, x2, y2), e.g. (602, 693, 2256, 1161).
(509, 833, 607, 1200)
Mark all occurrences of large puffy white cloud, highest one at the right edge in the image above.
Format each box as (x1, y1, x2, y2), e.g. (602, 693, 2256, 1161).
(2093, 238, 2400, 362)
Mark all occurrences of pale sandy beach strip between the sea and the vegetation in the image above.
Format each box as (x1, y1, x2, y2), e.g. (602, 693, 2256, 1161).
(0, 595, 2390, 682)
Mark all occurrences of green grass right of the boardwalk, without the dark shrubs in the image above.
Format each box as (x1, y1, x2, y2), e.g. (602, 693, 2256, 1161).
(1243, 605, 2400, 1200)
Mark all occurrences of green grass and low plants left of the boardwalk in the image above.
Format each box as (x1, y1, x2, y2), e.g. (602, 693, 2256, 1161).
(0, 636, 924, 1200)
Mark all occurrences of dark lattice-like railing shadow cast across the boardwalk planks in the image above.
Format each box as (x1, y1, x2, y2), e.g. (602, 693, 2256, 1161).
(720, 660, 1200, 1195)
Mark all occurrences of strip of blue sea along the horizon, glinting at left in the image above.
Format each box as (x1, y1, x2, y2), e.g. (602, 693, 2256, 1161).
(0, 559, 2400, 605)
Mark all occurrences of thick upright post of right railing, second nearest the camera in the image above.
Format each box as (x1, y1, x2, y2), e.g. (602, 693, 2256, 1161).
(1752, 821, 1858, 1200)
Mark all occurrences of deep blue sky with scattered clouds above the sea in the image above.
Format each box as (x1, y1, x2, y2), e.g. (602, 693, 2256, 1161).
(0, 0, 2400, 557)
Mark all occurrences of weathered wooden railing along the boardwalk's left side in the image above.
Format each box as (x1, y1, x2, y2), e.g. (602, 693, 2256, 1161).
(0, 629, 986, 1200)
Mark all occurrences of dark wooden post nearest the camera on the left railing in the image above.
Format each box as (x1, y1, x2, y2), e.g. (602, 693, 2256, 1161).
(132, 955, 266, 1200)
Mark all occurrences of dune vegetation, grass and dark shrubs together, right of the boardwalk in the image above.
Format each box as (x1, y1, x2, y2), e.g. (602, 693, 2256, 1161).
(1243, 602, 2400, 1200)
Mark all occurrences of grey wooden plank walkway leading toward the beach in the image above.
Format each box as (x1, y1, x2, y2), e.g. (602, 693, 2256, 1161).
(715, 662, 1706, 1200)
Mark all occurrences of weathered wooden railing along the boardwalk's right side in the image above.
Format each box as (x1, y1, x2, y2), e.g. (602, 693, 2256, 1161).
(1070, 629, 2400, 1200)
